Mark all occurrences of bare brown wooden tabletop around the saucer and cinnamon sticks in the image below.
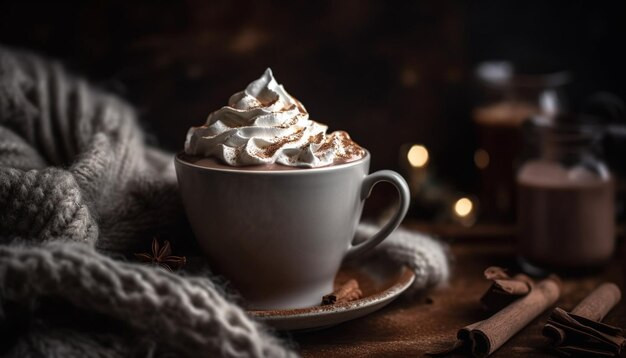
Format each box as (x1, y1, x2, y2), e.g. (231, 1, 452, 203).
(288, 224, 626, 357)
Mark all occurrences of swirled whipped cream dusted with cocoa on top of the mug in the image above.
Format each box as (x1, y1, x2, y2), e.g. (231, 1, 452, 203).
(185, 68, 365, 168)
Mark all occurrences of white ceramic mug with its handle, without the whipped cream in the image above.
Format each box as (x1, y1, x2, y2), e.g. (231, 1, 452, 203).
(175, 153, 409, 309)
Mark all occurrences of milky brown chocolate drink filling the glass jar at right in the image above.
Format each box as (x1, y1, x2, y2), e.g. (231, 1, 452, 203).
(517, 160, 615, 269)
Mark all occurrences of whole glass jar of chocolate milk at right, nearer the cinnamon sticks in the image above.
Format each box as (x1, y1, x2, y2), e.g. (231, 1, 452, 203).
(516, 116, 615, 274)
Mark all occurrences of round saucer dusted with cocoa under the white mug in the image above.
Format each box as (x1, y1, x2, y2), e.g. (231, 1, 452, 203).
(248, 258, 415, 331)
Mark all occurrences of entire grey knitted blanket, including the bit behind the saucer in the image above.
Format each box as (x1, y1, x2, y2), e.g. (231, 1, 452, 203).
(0, 47, 448, 357)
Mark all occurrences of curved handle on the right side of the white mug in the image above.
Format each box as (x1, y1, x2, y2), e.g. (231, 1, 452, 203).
(345, 170, 410, 259)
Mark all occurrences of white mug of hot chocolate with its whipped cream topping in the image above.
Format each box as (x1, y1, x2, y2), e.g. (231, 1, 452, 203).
(174, 69, 410, 310)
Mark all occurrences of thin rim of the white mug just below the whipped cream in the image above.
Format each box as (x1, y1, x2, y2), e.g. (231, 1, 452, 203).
(174, 148, 370, 175)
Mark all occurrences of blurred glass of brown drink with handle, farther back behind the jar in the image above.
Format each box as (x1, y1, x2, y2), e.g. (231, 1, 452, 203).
(472, 62, 569, 222)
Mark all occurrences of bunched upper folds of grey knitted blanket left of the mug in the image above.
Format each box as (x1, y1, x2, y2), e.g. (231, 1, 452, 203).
(0, 48, 180, 253)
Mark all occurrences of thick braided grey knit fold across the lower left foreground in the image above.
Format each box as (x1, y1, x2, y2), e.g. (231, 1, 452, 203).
(0, 242, 289, 357)
